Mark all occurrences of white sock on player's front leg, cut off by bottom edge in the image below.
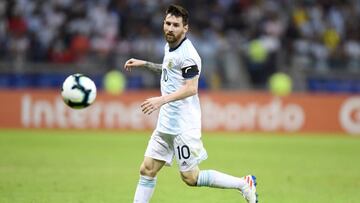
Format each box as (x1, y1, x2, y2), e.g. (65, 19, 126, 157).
(134, 176, 156, 203)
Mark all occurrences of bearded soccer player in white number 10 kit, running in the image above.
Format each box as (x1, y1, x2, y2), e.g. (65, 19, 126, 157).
(124, 5, 257, 203)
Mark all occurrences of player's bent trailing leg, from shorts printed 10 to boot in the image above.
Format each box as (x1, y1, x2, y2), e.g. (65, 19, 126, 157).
(174, 131, 256, 203)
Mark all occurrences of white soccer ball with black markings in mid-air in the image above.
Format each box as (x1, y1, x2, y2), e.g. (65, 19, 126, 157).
(61, 73, 96, 109)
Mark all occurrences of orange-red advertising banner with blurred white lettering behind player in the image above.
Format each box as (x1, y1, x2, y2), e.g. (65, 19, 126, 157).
(0, 90, 360, 135)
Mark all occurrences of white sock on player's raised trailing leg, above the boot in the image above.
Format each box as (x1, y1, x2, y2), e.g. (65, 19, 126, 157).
(197, 170, 246, 189)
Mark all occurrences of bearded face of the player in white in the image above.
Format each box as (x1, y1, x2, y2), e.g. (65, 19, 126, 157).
(164, 14, 188, 44)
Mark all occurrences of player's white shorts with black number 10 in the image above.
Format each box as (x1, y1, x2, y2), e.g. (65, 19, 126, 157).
(145, 129, 208, 172)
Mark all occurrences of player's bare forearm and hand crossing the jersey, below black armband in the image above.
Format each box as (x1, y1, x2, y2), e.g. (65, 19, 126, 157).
(141, 76, 199, 114)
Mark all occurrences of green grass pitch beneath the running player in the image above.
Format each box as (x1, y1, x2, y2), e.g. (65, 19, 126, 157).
(0, 130, 360, 203)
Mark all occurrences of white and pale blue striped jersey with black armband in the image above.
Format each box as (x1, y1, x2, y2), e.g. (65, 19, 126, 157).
(156, 37, 201, 135)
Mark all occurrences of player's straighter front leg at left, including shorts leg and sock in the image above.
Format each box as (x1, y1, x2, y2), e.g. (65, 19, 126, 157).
(134, 131, 174, 203)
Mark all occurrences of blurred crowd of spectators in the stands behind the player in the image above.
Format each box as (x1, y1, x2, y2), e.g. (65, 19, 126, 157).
(0, 0, 360, 89)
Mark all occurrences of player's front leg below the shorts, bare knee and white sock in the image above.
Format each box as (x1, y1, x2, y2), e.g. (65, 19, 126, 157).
(134, 157, 165, 203)
